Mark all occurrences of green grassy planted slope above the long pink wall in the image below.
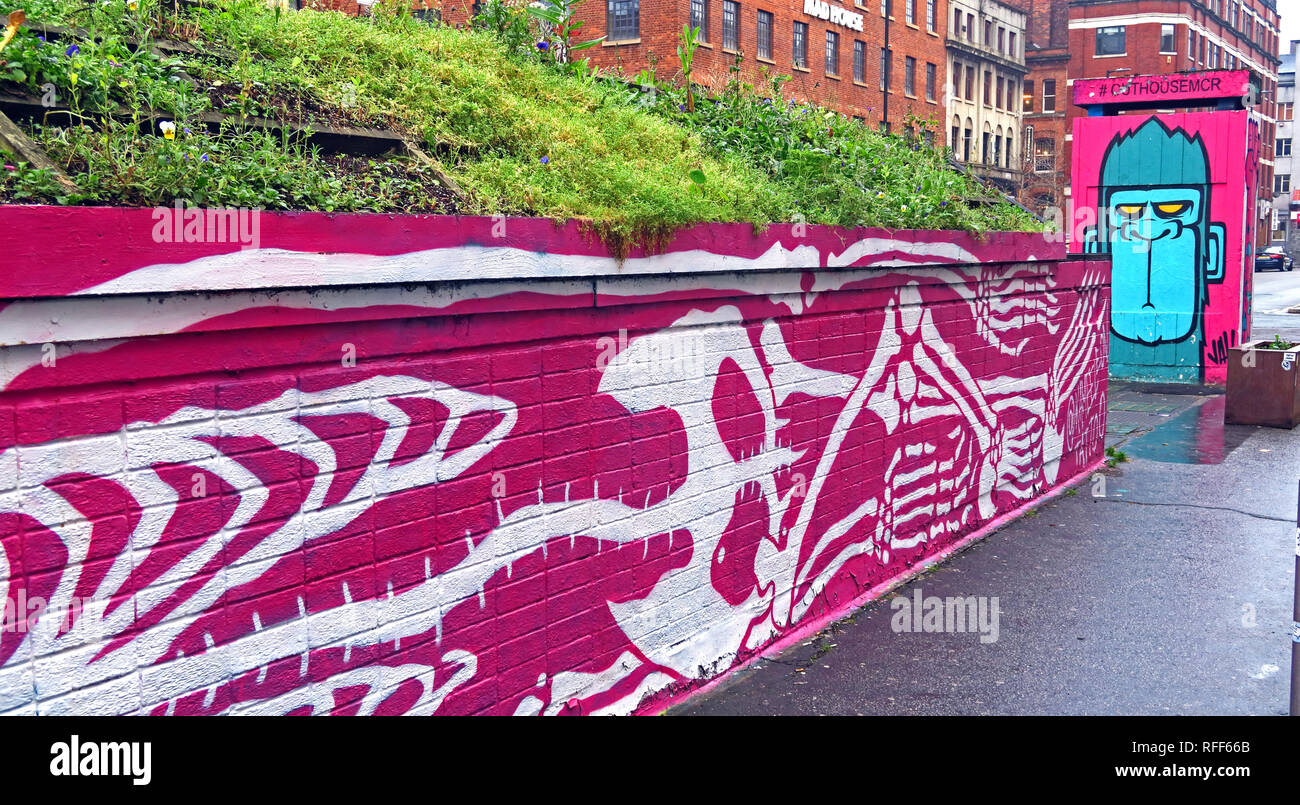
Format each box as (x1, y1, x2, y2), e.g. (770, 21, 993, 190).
(0, 0, 1039, 242)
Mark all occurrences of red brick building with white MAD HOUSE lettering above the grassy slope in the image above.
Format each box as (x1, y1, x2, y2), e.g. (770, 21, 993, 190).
(580, 0, 948, 129)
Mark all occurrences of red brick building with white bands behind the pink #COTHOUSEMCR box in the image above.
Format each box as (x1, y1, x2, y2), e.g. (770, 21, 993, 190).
(1057, 0, 1282, 246)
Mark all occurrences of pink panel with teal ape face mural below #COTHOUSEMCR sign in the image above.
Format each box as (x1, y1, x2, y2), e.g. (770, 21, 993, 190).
(1074, 112, 1253, 382)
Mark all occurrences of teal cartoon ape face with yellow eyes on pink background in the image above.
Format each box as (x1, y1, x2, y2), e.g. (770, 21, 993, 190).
(1087, 118, 1223, 345)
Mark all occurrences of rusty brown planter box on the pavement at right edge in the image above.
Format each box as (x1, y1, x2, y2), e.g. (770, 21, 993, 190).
(1223, 341, 1300, 428)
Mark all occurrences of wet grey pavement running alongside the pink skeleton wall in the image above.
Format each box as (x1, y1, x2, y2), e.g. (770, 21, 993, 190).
(672, 384, 1300, 715)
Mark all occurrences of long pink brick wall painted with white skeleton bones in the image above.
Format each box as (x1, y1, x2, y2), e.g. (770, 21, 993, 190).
(0, 207, 1108, 714)
